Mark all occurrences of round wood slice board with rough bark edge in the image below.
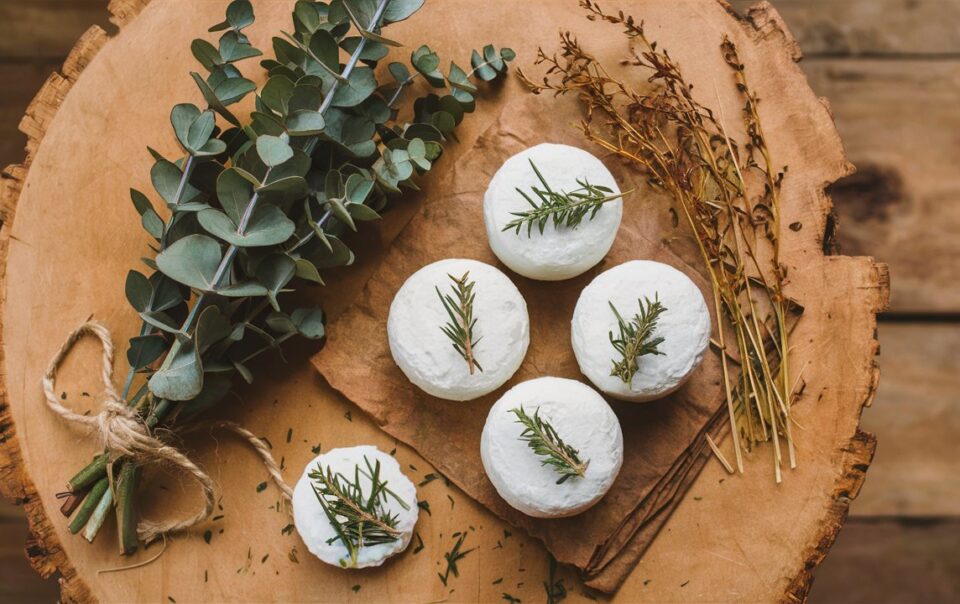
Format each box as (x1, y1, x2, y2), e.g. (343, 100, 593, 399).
(0, 0, 888, 602)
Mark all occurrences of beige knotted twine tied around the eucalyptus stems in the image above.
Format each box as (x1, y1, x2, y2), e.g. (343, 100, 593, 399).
(43, 321, 293, 543)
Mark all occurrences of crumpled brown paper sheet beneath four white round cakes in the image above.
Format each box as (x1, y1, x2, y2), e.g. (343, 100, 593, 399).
(313, 96, 725, 592)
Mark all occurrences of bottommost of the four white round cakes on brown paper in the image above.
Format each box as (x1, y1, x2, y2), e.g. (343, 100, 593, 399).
(480, 377, 623, 518)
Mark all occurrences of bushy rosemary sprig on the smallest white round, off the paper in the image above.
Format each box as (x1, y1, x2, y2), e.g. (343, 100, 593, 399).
(309, 456, 410, 568)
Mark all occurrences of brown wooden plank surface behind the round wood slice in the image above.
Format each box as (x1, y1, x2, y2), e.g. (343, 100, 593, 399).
(0, 0, 960, 602)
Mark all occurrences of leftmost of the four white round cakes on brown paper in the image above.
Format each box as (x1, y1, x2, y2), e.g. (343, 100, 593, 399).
(387, 259, 530, 401)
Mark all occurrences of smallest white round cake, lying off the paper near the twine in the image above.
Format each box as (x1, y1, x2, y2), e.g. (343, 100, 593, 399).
(293, 445, 420, 568)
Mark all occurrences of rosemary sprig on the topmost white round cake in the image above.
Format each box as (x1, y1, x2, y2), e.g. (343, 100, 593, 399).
(501, 159, 631, 237)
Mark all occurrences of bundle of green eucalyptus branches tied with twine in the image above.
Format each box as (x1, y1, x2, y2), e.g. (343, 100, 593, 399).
(53, 0, 514, 554)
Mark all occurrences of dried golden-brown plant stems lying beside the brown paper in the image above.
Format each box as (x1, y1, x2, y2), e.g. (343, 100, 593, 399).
(520, 0, 802, 482)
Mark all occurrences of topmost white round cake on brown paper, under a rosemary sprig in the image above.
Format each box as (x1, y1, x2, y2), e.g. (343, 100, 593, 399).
(483, 143, 623, 281)
